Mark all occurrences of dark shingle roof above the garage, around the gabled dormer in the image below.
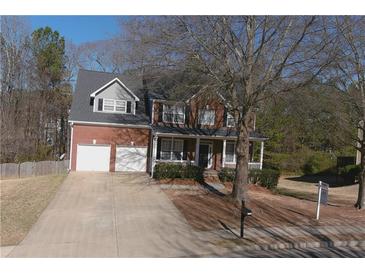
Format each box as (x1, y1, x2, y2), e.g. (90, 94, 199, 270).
(69, 69, 149, 125)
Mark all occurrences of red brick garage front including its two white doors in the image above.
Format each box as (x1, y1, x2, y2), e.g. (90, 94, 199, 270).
(70, 124, 150, 172)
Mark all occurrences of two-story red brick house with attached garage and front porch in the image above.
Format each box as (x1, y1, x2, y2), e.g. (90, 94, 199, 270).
(69, 70, 267, 172)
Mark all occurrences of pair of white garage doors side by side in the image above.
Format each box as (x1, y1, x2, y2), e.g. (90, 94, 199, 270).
(76, 144, 147, 172)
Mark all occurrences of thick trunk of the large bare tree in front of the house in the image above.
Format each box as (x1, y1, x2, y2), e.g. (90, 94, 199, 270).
(231, 113, 249, 203)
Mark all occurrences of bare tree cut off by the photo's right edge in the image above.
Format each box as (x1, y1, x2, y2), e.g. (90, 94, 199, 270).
(329, 16, 365, 209)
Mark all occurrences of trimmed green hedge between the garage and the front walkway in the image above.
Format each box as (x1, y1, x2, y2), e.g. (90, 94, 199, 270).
(153, 163, 203, 182)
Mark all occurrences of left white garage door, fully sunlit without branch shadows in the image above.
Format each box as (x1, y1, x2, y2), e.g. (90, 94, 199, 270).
(76, 145, 110, 171)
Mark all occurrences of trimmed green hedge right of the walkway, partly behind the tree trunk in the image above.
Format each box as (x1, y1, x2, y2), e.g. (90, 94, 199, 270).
(218, 168, 280, 189)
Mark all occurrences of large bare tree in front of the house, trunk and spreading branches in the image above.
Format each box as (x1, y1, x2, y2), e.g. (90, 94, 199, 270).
(121, 16, 333, 202)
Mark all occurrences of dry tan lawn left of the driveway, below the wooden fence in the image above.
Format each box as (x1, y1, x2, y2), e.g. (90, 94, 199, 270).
(0, 175, 66, 246)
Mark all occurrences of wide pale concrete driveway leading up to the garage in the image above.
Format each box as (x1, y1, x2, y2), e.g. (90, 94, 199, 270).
(8, 172, 215, 257)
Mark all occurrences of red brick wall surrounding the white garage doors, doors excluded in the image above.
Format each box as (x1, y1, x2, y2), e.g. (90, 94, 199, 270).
(71, 124, 150, 171)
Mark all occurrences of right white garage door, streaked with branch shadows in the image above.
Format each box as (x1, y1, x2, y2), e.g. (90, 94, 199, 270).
(115, 147, 147, 171)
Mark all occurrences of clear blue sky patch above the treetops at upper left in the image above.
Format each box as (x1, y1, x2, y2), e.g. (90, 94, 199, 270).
(29, 16, 123, 44)
